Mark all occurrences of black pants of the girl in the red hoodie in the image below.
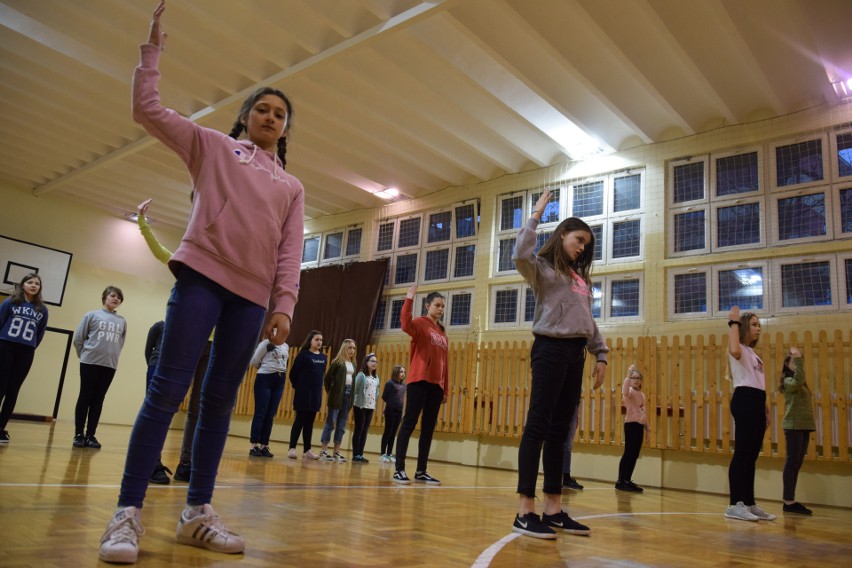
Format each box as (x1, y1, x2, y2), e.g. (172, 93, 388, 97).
(396, 381, 444, 472)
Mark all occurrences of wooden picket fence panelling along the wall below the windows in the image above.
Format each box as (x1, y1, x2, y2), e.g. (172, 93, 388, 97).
(190, 331, 852, 462)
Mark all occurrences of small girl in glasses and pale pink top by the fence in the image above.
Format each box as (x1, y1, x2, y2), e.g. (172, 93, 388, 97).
(615, 365, 651, 493)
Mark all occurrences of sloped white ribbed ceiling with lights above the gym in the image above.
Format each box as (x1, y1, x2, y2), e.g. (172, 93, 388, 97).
(0, 0, 852, 228)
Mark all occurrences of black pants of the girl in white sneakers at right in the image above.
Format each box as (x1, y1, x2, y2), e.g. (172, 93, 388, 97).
(728, 387, 766, 506)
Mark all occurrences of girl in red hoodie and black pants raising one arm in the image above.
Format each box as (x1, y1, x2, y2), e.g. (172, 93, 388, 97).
(393, 286, 450, 485)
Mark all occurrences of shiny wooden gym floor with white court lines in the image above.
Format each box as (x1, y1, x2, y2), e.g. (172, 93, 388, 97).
(0, 420, 852, 568)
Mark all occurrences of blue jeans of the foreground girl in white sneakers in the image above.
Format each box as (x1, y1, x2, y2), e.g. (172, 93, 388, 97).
(118, 266, 266, 507)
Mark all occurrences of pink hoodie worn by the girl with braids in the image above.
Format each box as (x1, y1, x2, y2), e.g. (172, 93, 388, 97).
(133, 44, 305, 318)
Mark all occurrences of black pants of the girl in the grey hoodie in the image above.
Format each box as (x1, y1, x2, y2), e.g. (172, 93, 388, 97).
(512, 335, 586, 497)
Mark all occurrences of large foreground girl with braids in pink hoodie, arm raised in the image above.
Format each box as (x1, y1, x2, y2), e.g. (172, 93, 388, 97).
(100, 0, 305, 563)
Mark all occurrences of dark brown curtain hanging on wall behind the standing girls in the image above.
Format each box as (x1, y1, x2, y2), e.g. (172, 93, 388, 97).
(287, 258, 389, 364)
